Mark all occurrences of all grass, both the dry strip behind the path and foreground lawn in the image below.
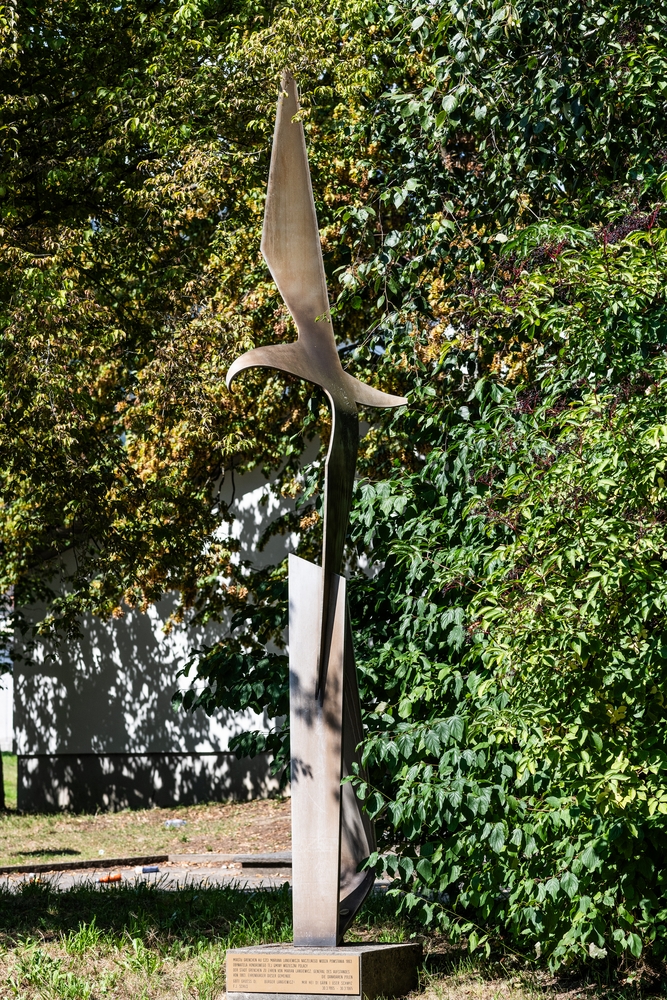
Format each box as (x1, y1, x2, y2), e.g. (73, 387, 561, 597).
(0, 796, 667, 1000)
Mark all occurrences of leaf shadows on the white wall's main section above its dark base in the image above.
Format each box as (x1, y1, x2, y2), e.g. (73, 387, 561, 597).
(14, 598, 260, 755)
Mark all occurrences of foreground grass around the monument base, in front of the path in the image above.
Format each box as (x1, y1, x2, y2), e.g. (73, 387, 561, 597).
(0, 882, 667, 1000)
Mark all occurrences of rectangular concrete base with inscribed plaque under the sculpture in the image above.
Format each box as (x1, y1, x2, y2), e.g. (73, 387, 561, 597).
(227, 943, 422, 1000)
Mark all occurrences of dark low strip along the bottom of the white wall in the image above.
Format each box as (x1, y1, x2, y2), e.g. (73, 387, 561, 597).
(18, 753, 278, 813)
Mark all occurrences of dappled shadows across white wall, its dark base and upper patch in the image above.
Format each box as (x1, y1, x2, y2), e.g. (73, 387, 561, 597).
(14, 460, 306, 811)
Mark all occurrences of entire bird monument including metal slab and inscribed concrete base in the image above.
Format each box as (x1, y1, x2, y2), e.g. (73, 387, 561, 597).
(227, 71, 421, 1000)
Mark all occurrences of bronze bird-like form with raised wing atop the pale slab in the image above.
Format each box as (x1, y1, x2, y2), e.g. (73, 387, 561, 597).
(227, 70, 407, 687)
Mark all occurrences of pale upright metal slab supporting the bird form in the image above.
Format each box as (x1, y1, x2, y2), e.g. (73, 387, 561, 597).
(289, 555, 346, 948)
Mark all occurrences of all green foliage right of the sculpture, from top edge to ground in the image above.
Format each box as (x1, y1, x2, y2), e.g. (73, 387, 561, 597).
(336, 3, 667, 965)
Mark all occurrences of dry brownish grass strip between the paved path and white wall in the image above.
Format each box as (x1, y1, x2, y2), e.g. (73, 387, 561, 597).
(0, 796, 291, 865)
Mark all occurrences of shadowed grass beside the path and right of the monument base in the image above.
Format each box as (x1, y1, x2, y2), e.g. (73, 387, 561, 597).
(0, 881, 667, 1000)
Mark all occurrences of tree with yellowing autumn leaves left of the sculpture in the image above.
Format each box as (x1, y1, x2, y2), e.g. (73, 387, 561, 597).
(0, 0, 410, 632)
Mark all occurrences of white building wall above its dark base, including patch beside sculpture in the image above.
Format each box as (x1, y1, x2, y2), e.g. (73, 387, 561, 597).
(11, 458, 308, 808)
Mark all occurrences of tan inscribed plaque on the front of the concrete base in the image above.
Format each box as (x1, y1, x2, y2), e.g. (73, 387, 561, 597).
(227, 952, 359, 996)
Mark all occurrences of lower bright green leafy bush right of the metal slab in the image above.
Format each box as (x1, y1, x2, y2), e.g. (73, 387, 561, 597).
(355, 233, 667, 964)
